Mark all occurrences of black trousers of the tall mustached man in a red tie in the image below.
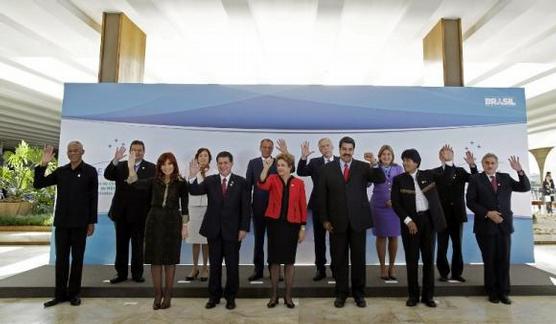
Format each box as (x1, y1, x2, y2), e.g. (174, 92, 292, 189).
(330, 227, 367, 298)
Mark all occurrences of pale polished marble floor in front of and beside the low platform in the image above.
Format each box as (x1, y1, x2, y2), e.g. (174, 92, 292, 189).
(0, 245, 556, 324)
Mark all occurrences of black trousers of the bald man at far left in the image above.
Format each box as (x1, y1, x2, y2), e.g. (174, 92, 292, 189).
(54, 226, 87, 299)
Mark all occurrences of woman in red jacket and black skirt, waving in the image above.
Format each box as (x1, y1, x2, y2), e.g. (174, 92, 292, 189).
(257, 153, 307, 308)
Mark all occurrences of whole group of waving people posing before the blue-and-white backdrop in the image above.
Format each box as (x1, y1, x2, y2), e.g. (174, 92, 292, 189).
(34, 136, 530, 309)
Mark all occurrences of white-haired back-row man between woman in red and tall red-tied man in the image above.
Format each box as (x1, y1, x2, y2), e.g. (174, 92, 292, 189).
(297, 137, 339, 281)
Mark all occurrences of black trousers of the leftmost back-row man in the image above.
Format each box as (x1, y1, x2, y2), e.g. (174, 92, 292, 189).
(114, 219, 145, 278)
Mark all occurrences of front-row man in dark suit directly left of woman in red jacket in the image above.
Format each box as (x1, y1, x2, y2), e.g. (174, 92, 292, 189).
(189, 151, 251, 309)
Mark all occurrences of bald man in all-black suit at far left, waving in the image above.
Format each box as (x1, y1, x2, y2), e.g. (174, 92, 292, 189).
(33, 141, 98, 307)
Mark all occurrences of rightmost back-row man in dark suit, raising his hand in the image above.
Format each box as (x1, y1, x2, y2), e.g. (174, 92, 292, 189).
(432, 145, 477, 282)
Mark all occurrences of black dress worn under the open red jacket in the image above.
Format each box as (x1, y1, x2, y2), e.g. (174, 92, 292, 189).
(265, 177, 301, 264)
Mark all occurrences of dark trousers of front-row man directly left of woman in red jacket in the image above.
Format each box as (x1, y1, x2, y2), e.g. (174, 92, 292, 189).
(208, 237, 241, 299)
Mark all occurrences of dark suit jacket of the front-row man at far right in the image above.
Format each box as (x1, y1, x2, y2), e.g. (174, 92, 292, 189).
(467, 172, 531, 235)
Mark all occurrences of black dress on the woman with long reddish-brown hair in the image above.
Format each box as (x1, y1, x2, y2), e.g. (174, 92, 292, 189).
(133, 178, 188, 265)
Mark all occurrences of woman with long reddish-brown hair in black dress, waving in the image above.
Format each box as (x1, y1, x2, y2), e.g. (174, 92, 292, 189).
(127, 152, 188, 310)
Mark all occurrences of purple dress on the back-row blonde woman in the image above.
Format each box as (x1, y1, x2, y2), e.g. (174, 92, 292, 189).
(371, 164, 404, 237)
